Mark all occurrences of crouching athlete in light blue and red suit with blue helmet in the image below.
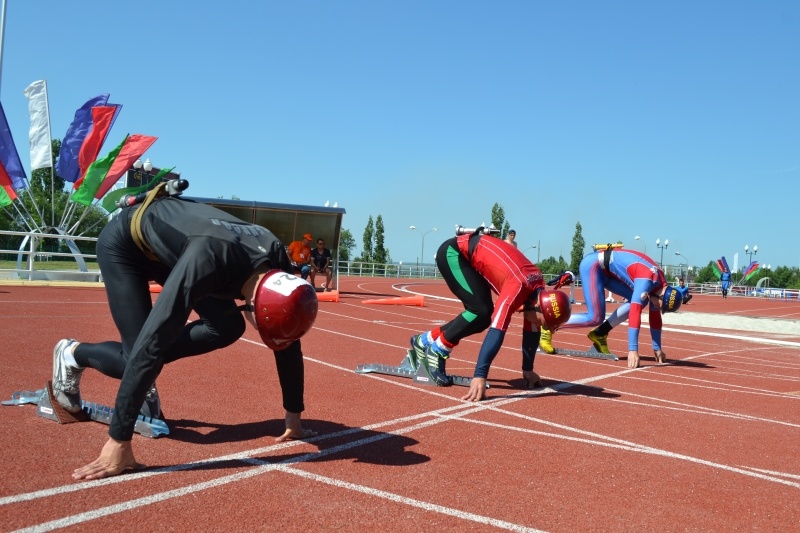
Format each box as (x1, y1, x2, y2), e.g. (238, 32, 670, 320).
(539, 248, 682, 368)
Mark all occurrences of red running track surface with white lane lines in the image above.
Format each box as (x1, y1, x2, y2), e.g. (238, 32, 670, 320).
(0, 278, 800, 532)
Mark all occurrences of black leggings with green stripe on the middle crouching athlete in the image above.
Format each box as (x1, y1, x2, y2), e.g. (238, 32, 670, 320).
(436, 237, 494, 346)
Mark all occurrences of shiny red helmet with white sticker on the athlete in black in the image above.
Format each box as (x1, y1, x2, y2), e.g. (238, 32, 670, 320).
(253, 270, 318, 350)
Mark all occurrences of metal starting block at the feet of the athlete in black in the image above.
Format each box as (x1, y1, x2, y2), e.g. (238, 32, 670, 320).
(0, 381, 169, 439)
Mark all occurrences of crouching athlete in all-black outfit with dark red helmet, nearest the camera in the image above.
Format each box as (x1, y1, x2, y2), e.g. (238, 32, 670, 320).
(53, 193, 317, 479)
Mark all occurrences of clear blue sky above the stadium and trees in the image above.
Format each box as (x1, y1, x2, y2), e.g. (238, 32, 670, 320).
(0, 0, 800, 268)
